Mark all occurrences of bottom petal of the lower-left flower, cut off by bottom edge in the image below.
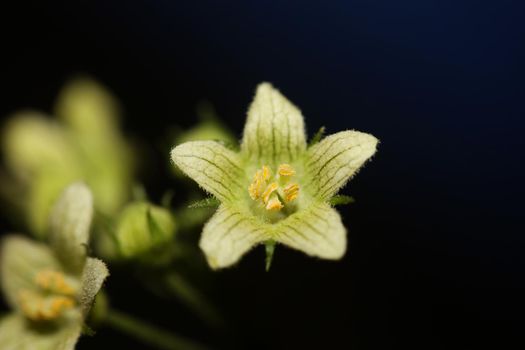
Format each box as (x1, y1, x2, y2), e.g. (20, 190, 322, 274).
(0, 313, 82, 350)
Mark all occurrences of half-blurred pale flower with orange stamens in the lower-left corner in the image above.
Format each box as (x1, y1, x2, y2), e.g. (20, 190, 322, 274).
(0, 183, 109, 350)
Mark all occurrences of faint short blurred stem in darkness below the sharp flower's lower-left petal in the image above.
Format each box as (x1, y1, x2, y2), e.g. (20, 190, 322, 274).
(166, 271, 223, 327)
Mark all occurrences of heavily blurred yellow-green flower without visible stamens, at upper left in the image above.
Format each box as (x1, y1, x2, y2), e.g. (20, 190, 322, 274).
(0, 77, 133, 237)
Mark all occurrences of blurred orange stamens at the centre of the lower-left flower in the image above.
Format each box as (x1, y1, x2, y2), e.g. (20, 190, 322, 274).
(18, 270, 77, 321)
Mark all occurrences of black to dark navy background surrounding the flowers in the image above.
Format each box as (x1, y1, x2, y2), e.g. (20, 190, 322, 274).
(0, 0, 525, 350)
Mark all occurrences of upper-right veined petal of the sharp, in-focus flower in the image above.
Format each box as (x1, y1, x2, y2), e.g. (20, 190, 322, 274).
(303, 131, 378, 200)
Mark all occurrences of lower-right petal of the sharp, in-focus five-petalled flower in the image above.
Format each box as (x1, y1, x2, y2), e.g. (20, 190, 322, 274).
(274, 203, 346, 260)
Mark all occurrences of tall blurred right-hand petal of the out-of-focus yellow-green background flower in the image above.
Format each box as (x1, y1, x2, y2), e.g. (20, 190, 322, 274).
(56, 77, 133, 215)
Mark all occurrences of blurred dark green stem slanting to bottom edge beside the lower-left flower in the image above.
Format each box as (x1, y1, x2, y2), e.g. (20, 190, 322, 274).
(105, 310, 207, 350)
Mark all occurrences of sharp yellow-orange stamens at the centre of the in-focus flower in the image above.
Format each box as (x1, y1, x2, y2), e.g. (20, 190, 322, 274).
(248, 164, 299, 211)
